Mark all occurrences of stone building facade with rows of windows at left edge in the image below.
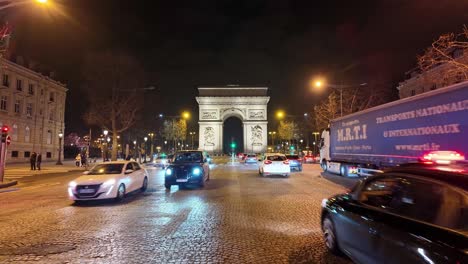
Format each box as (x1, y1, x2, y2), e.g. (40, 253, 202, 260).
(0, 58, 67, 163)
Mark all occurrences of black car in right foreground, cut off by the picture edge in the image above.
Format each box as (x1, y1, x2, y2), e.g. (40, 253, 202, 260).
(321, 164, 468, 263)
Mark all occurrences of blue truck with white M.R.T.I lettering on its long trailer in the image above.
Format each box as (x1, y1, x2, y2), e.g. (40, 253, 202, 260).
(320, 82, 468, 176)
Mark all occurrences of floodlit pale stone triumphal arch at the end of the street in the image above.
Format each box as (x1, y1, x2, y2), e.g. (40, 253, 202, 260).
(197, 86, 270, 153)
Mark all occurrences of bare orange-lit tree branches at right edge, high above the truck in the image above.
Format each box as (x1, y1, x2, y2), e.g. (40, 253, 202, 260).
(418, 26, 468, 81)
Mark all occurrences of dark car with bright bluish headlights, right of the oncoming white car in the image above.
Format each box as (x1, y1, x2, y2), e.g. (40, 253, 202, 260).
(164, 151, 210, 189)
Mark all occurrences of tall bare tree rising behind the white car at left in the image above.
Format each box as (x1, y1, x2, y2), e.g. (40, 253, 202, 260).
(84, 52, 144, 160)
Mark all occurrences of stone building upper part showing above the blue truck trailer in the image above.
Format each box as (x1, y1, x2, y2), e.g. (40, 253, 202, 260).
(397, 49, 468, 98)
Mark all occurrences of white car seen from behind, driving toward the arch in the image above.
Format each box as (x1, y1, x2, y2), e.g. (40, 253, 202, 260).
(258, 153, 291, 177)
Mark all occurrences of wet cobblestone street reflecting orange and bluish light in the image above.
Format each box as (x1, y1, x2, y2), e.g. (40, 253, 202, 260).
(0, 161, 351, 263)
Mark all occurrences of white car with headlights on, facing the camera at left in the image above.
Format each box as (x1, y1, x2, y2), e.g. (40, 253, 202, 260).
(68, 161, 148, 201)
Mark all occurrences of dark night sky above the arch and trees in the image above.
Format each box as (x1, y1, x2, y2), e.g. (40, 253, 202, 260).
(3, 0, 468, 132)
